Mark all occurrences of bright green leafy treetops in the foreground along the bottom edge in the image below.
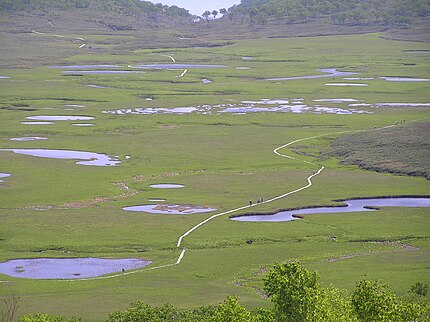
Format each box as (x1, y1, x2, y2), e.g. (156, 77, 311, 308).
(10, 262, 430, 322)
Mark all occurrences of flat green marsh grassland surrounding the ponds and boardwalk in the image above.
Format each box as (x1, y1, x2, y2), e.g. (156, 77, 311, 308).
(0, 29, 430, 321)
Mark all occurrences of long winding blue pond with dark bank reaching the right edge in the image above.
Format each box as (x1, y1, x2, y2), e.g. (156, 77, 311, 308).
(230, 198, 430, 222)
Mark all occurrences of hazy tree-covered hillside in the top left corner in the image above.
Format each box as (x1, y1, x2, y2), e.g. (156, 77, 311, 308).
(0, 0, 193, 30)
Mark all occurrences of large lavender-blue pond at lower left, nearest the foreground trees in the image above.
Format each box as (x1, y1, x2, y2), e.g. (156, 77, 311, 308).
(0, 258, 152, 279)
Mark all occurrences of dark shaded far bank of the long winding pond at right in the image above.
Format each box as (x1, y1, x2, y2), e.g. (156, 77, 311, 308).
(228, 195, 430, 219)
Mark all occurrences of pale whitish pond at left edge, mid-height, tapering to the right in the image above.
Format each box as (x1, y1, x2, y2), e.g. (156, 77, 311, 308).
(0, 149, 121, 166)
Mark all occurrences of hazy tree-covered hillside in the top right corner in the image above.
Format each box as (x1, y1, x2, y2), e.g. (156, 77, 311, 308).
(203, 0, 430, 25)
